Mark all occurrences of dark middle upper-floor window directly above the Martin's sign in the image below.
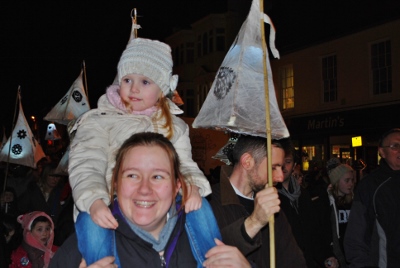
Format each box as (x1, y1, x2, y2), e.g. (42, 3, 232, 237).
(322, 55, 337, 102)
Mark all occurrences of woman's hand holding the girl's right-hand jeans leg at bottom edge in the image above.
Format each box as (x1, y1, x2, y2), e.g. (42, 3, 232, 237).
(203, 239, 251, 268)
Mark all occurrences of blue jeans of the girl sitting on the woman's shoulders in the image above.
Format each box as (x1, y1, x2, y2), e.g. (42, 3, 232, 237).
(75, 195, 222, 268)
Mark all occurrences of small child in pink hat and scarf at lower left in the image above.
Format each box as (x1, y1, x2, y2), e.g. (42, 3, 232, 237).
(9, 211, 57, 268)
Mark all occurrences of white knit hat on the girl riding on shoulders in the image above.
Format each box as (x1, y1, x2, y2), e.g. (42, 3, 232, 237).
(118, 38, 178, 96)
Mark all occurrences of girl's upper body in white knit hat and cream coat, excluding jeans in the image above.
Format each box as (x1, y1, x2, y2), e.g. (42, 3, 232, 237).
(68, 38, 211, 229)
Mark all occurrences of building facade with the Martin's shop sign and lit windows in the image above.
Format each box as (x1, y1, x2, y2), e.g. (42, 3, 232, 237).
(271, 20, 400, 174)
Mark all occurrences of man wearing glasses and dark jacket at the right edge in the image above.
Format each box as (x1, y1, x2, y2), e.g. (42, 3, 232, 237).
(344, 128, 400, 267)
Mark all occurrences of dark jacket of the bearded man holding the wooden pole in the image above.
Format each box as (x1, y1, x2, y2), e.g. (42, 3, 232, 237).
(209, 166, 306, 268)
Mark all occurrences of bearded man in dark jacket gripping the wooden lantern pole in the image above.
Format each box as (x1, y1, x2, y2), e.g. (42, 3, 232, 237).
(210, 135, 306, 267)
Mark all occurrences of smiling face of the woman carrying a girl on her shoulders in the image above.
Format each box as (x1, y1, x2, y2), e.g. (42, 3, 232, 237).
(116, 146, 180, 239)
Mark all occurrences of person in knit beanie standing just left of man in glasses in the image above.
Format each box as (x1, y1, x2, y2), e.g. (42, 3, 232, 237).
(327, 158, 355, 267)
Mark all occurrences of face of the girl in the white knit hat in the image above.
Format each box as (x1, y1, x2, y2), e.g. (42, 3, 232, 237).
(119, 74, 161, 111)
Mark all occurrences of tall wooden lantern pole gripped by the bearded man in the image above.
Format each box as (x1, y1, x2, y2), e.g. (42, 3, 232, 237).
(259, 0, 275, 268)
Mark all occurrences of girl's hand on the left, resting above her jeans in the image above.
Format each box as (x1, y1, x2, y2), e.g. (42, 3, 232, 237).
(89, 199, 118, 229)
